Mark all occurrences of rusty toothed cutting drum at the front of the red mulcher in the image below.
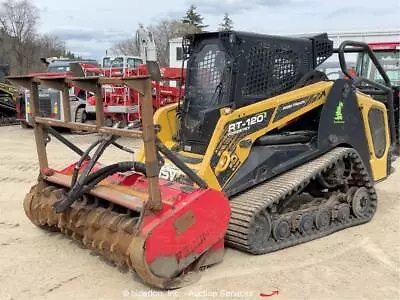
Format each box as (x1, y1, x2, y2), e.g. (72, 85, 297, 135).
(24, 182, 155, 284)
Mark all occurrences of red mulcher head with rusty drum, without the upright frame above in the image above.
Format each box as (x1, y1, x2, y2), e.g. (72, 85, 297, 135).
(24, 164, 230, 289)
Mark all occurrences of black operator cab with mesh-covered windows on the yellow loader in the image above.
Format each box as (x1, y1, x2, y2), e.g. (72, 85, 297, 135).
(180, 31, 333, 154)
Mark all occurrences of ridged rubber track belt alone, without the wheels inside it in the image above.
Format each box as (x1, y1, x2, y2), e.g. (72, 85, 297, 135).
(225, 148, 377, 254)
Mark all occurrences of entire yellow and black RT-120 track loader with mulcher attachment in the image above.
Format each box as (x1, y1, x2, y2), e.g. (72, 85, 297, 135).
(10, 32, 397, 289)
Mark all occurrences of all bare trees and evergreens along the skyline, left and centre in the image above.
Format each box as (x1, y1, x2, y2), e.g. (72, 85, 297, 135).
(0, 0, 233, 75)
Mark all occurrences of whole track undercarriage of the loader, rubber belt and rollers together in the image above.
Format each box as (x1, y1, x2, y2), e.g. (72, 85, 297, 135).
(225, 148, 377, 254)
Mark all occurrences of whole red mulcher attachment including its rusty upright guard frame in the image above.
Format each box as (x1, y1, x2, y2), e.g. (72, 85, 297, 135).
(10, 76, 230, 289)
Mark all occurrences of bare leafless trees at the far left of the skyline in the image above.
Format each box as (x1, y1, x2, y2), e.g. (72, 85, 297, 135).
(0, 0, 75, 75)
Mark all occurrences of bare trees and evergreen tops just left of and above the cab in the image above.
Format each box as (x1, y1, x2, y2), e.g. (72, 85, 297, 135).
(111, 5, 233, 66)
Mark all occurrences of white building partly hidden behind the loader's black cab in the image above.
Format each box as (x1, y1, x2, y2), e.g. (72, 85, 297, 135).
(169, 29, 400, 68)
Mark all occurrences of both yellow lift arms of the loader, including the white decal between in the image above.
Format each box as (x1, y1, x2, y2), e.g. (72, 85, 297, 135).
(139, 82, 333, 190)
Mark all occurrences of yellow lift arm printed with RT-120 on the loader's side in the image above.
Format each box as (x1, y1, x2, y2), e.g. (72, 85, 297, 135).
(199, 82, 332, 190)
